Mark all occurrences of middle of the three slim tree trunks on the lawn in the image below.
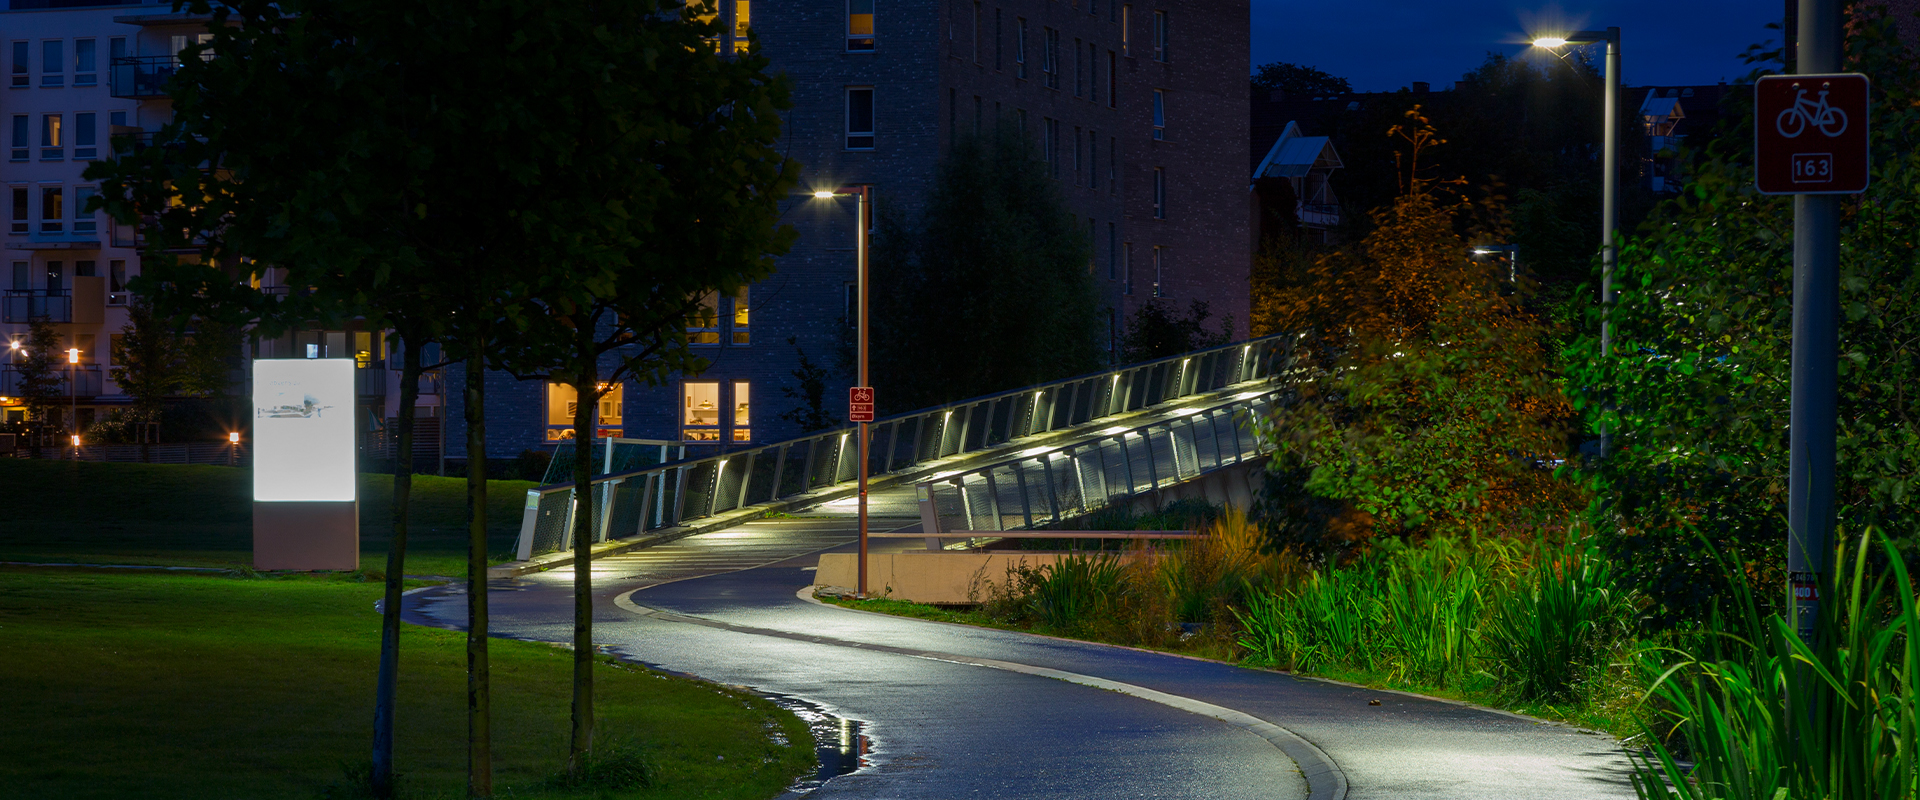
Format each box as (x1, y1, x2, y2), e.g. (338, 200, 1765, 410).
(465, 352, 493, 798)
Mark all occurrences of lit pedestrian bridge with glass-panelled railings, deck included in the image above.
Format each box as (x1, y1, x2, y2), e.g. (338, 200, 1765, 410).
(505, 329, 1290, 574)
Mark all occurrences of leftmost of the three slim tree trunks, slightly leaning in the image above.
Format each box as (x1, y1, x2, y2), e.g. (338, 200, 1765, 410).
(372, 336, 424, 800)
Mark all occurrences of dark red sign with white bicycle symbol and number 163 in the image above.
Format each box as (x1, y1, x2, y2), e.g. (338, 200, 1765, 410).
(1753, 73, 1870, 194)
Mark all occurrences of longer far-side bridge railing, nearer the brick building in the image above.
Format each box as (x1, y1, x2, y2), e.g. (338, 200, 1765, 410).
(516, 334, 1292, 560)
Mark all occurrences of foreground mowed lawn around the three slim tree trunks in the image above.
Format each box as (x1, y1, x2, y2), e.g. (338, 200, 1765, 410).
(0, 568, 814, 800)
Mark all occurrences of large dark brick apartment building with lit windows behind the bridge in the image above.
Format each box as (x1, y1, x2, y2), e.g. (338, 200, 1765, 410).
(447, 0, 1252, 457)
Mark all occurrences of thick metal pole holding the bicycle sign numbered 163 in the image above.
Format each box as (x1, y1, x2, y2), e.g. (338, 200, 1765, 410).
(1788, 0, 1841, 645)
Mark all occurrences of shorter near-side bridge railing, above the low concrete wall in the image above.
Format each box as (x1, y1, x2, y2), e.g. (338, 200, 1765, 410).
(914, 386, 1283, 533)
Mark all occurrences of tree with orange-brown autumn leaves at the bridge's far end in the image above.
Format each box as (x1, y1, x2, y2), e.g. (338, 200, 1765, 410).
(1260, 111, 1569, 556)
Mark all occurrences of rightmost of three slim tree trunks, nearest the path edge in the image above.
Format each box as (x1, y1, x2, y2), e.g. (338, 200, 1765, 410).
(566, 322, 595, 779)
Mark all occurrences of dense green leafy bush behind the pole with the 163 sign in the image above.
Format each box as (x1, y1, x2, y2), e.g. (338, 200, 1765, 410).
(1567, 12, 1920, 625)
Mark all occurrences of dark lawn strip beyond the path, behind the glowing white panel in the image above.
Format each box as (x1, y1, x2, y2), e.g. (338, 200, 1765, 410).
(0, 459, 534, 576)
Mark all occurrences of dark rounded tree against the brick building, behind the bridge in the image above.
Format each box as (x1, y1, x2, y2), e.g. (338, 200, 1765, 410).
(870, 125, 1100, 411)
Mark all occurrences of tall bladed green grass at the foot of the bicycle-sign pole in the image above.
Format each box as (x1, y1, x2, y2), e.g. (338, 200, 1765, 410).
(1634, 531, 1920, 800)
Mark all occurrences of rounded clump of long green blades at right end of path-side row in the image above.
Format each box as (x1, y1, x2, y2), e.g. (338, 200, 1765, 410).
(1482, 539, 1632, 702)
